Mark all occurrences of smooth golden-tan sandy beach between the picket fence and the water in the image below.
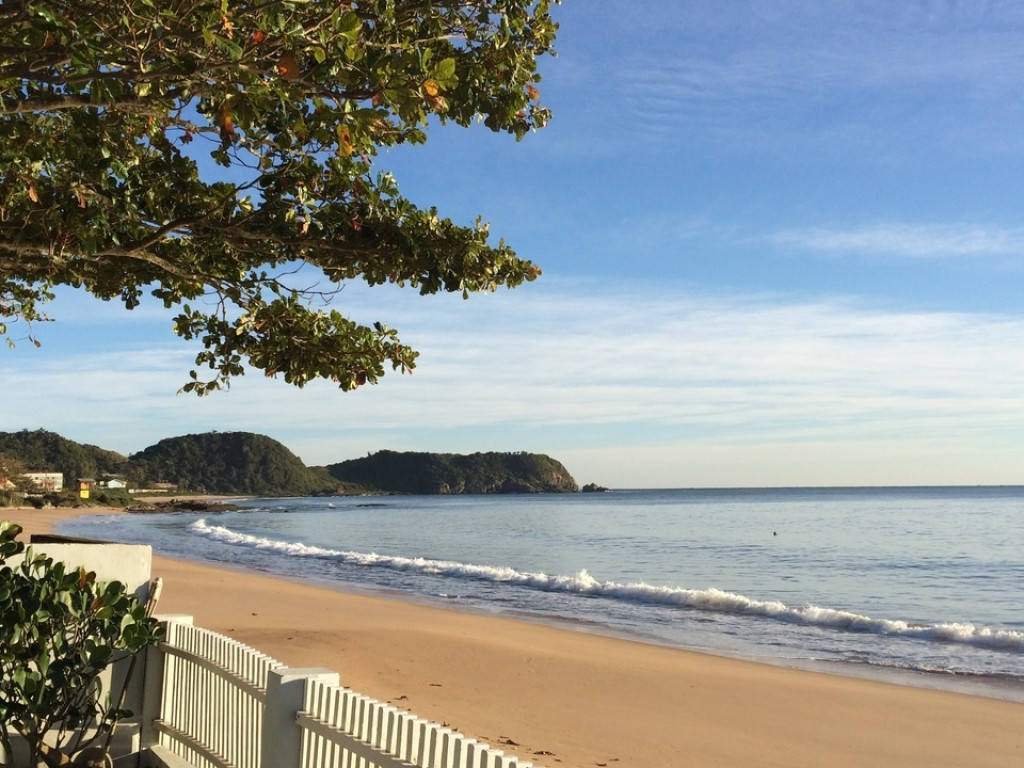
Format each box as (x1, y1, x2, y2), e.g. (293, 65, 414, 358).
(0, 509, 1024, 768)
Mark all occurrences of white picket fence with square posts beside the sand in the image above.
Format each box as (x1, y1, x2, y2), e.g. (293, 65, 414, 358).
(141, 617, 534, 768)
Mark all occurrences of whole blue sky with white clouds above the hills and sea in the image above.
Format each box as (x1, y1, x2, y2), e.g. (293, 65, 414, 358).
(0, 0, 1024, 487)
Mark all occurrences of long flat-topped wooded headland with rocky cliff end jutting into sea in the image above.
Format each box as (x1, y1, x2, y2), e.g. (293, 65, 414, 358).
(327, 451, 580, 494)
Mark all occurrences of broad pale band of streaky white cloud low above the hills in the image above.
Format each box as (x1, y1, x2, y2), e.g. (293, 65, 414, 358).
(8, 286, 1024, 487)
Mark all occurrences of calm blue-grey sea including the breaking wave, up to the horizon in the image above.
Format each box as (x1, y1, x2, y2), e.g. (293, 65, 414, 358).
(59, 486, 1024, 701)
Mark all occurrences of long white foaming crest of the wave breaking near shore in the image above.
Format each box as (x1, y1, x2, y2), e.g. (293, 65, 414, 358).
(188, 519, 1024, 651)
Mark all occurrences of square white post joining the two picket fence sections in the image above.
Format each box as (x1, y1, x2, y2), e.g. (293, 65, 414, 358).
(260, 667, 340, 768)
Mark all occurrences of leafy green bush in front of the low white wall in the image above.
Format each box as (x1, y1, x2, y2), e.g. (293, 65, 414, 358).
(0, 522, 159, 766)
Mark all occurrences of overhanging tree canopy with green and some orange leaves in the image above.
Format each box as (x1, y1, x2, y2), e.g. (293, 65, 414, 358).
(0, 0, 557, 394)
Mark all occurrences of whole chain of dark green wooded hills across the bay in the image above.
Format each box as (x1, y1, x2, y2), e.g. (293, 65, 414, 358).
(0, 429, 580, 499)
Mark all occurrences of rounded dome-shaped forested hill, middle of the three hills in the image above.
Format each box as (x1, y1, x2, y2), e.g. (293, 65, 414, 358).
(131, 432, 340, 496)
